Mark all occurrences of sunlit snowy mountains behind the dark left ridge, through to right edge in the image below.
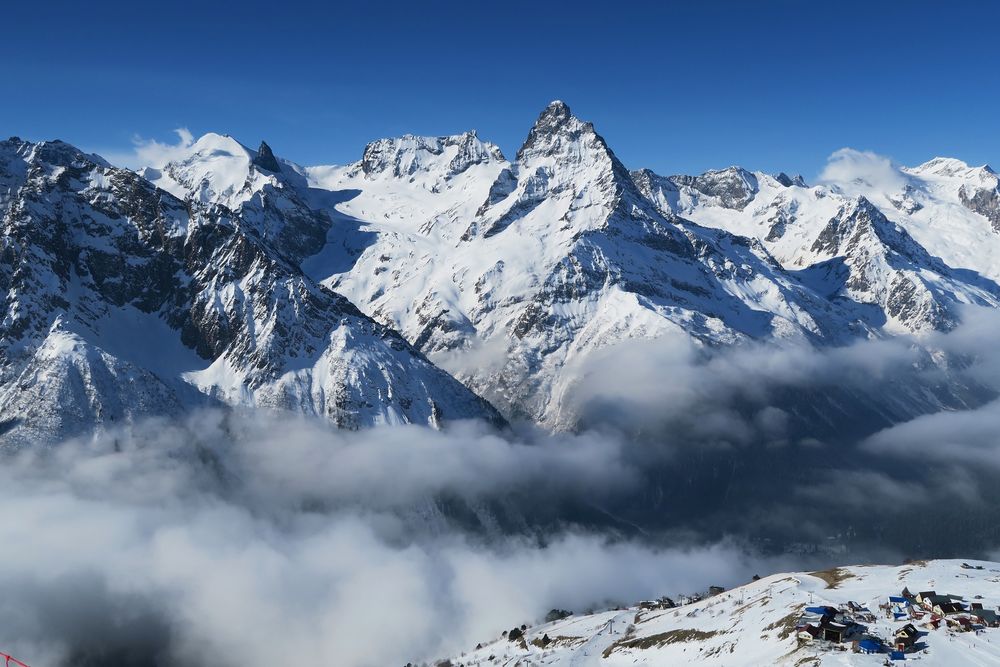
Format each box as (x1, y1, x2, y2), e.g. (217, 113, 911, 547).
(147, 102, 1000, 428)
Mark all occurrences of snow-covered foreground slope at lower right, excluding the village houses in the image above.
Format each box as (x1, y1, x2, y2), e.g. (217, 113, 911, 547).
(439, 560, 1000, 667)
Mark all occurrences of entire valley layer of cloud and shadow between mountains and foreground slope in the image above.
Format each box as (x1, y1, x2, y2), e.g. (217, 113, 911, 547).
(9, 310, 1000, 667)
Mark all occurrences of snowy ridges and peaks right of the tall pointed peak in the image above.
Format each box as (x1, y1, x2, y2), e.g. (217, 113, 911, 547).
(633, 158, 1000, 333)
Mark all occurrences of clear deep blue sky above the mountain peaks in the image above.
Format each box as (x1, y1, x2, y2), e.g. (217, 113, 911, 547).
(0, 0, 1000, 176)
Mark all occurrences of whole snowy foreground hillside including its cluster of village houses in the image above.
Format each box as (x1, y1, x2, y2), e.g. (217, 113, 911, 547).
(435, 561, 1000, 667)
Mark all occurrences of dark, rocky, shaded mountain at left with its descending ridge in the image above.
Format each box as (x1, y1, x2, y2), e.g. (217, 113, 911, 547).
(0, 139, 499, 441)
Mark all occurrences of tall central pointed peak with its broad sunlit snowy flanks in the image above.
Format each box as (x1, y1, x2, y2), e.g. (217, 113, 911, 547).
(290, 102, 892, 426)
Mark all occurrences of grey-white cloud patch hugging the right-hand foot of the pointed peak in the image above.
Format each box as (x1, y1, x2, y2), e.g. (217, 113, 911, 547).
(563, 328, 924, 446)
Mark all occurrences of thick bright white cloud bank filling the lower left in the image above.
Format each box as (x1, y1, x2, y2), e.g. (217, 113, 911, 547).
(0, 412, 766, 666)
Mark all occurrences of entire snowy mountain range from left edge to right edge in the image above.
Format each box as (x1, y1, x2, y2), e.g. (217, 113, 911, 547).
(0, 102, 1000, 444)
